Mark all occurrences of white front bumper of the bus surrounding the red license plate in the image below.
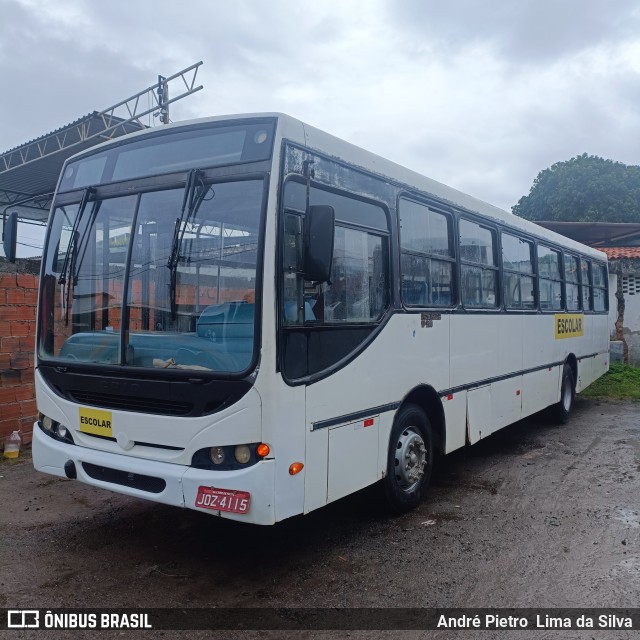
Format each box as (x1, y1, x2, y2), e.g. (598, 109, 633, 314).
(33, 422, 275, 524)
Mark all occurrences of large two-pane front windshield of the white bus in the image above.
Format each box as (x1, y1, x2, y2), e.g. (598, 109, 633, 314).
(38, 178, 265, 373)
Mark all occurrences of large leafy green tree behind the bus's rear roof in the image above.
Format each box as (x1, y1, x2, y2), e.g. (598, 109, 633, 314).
(512, 153, 640, 222)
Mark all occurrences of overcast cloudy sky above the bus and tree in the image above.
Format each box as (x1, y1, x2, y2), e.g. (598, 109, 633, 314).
(0, 0, 640, 214)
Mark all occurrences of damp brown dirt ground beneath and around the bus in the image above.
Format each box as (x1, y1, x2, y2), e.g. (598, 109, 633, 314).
(0, 398, 640, 639)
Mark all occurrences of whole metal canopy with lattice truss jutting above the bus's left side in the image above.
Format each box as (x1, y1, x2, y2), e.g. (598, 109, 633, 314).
(0, 61, 202, 221)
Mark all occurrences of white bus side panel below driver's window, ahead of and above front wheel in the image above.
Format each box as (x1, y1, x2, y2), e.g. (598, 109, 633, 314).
(304, 313, 451, 512)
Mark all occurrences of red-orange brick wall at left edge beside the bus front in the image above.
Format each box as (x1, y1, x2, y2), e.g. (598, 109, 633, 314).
(0, 259, 39, 444)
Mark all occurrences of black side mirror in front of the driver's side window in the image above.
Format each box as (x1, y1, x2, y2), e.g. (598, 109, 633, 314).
(302, 205, 336, 282)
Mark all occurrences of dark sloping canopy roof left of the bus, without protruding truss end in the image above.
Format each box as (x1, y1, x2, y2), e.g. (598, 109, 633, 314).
(0, 111, 146, 220)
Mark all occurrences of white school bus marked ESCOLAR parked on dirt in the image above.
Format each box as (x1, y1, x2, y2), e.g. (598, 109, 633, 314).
(33, 114, 609, 524)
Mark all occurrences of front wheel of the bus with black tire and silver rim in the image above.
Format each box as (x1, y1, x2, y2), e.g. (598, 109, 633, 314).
(382, 404, 434, 514)
